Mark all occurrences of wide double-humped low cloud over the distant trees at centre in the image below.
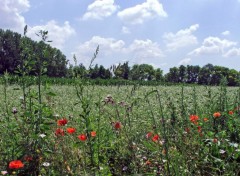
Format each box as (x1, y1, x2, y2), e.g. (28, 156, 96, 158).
(73, 36, 164, 65)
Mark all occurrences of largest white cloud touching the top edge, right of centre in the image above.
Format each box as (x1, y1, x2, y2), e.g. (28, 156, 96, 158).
(117, 0, 167, 24)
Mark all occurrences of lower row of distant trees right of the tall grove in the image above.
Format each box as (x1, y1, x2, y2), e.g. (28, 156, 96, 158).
(69, 62, 240, 86)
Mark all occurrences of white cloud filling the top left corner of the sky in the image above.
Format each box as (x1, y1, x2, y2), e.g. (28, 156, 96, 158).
(0, 0, 30, 32)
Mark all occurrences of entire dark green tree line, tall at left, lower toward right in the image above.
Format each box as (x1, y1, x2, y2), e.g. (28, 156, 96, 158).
(0, 29, 240, 86)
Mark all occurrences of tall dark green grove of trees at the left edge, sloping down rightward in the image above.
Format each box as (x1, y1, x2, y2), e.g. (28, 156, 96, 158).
(0, 29, 68, 77)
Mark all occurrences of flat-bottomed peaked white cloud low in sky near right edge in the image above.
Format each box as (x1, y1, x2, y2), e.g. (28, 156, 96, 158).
(189, 37, 237, 55)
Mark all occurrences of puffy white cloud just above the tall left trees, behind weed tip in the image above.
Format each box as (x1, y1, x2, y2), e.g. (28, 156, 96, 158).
(27, 20, 75, 49)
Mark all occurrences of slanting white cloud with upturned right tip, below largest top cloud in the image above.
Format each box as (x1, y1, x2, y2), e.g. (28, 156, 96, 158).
(163, 24, 199, 51)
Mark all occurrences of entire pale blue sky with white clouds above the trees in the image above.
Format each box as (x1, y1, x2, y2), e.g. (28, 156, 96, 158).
(0, 0, 240, 73)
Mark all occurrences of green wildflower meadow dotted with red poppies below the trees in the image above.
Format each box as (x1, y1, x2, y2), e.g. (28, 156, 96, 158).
(0, 81, 240, 176)
